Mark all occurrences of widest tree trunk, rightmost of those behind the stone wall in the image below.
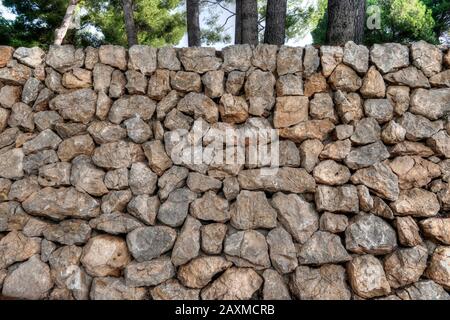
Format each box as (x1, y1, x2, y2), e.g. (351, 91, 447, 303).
(327, 0, 366, 45)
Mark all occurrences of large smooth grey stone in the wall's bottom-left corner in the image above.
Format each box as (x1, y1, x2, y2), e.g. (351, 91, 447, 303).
(2, 255, 53, 300)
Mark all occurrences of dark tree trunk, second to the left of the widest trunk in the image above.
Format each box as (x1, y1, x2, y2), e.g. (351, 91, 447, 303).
(241, 0, 258, 45)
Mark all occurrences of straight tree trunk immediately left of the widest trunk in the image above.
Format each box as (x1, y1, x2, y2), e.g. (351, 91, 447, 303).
(264, 0, 287, 45)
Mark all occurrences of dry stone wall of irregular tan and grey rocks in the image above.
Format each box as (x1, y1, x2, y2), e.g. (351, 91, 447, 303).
(0, 42, 450, 300)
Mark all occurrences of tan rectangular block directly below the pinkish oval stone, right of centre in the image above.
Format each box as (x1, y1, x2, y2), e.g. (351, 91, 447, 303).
(315, 185, 359, 213)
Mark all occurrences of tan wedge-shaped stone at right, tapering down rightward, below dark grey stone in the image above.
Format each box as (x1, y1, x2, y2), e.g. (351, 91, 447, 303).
(351, 163, 400, 201)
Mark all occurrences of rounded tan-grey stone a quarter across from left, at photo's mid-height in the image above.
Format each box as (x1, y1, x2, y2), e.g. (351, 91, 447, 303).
(92, 141, 131, 169)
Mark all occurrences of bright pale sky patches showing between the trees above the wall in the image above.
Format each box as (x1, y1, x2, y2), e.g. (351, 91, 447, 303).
(0, 0, 312, 50)
